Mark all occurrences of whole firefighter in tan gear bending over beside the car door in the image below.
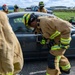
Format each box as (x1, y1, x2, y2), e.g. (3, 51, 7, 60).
(23, 13, 71, 75)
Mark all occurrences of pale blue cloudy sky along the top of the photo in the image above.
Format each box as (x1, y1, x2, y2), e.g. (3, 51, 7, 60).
(0, 0, 75, 7)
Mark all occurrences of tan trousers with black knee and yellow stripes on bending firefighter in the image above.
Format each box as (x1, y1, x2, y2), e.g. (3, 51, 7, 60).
(46, 49, 71, 75)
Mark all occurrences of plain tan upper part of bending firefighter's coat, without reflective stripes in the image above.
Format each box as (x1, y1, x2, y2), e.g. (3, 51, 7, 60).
(38, 17, 72, 40)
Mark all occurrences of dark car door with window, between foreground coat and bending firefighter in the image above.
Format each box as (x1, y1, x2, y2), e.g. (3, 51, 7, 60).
(9, 16, 43, 59)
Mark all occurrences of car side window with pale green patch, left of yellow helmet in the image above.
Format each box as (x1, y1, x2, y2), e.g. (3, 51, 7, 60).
(9, 16, 32, 34)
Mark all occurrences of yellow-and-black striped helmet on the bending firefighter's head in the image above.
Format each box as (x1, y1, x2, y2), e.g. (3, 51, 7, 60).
(23, 13, 37, 27)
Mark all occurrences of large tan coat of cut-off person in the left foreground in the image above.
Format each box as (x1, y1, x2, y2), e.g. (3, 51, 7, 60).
(0, 11, 23, 75)
